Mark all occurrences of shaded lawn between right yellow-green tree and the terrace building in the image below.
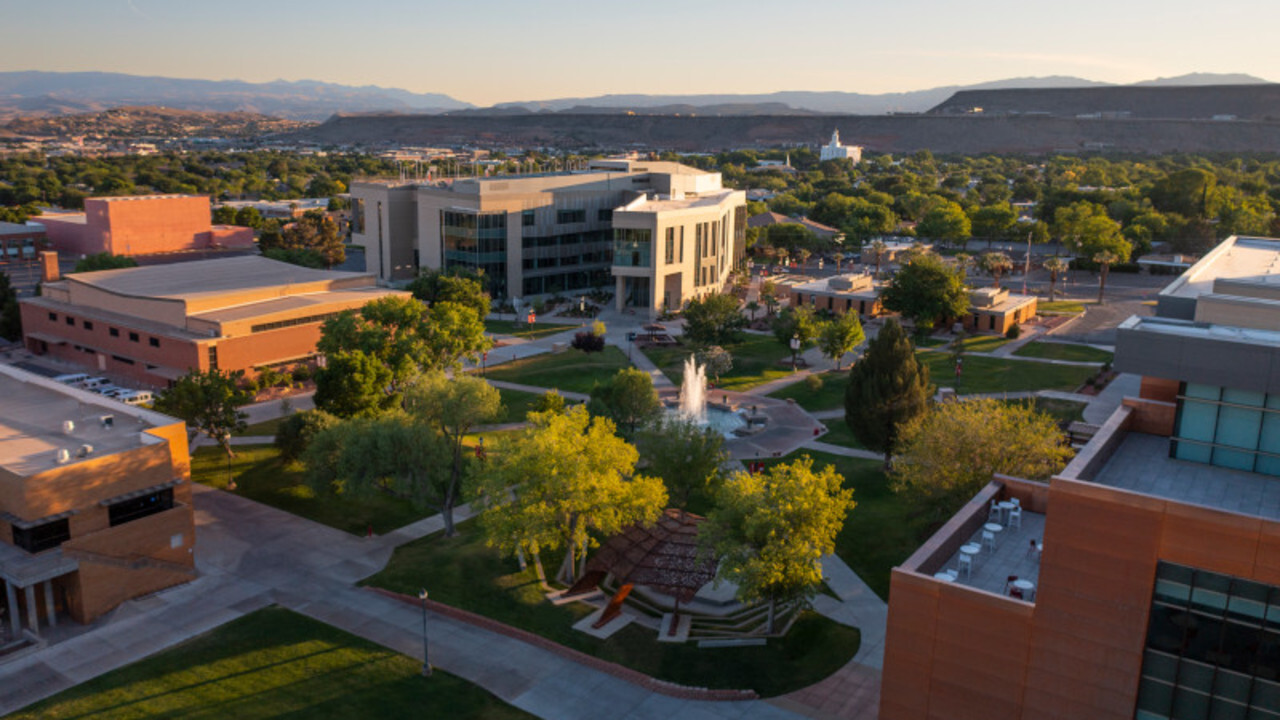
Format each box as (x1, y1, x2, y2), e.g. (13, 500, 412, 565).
(765, 448, 956, 601)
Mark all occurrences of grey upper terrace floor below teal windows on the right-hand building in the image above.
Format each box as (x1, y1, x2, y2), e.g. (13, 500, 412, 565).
(1094, 433, 1280, 520)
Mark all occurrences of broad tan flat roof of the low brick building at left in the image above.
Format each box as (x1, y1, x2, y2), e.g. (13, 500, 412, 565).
(65, 255, 374, 300)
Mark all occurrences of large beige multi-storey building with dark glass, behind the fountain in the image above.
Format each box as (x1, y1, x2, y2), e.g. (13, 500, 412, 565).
(351, 160, 746, 311)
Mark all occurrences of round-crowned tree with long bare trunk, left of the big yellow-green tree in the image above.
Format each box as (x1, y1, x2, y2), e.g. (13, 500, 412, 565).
(404, 370, 502, 537)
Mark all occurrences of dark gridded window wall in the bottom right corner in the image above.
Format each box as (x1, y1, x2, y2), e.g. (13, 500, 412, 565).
(1134, 562, 1280, 720)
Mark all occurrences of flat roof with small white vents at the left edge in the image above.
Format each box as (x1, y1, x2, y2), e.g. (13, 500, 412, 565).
(0, 365, 180, 475)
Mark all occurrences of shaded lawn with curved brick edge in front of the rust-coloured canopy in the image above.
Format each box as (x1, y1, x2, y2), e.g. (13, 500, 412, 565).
(365, 521, 859, 696)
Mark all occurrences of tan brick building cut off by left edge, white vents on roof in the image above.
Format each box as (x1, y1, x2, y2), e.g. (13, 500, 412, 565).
(0, 365, 196, 635)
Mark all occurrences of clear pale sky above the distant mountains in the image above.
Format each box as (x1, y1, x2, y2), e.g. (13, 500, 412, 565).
(0, 0, 1280, 105)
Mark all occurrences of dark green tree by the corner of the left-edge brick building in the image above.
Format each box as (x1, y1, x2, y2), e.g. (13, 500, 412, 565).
(155, 368, 248, 457)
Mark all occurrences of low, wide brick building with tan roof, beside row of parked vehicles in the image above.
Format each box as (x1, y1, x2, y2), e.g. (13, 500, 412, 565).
(20, 252, 404, 387)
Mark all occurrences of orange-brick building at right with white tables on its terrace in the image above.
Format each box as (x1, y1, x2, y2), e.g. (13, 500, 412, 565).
(881, 237, 1280, 720)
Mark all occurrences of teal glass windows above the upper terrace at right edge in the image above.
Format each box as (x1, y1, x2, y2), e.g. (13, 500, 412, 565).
(1171, 383, 1280, 475)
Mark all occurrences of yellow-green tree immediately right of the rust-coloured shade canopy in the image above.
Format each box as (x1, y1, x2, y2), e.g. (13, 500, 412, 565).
(700, 455, 855, 633)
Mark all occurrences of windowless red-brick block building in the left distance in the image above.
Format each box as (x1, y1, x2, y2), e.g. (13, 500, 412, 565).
(40, 195, 253, 256)
